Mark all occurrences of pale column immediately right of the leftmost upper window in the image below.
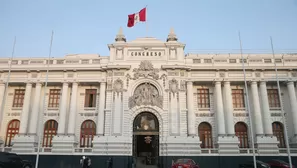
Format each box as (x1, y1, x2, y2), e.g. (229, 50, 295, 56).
(19, 82, 32, 134)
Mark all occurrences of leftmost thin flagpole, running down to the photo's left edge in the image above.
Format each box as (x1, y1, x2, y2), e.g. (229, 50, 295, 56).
(0, 36, 16, 133)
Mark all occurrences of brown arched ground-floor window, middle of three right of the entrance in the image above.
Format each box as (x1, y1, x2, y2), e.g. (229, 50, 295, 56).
(235, 122, 249, 148)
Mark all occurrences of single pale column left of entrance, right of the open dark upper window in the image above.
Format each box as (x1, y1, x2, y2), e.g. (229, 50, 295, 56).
(96, 82, 106, 135)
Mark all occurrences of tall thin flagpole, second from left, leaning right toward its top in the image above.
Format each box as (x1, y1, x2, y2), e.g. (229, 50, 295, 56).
(35, 31, 54, 168)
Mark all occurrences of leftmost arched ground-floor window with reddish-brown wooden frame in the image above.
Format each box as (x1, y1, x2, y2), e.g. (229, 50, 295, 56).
(5, 120, 20, 147)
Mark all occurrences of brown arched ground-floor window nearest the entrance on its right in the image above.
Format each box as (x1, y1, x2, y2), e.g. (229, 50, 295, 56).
(198, 122, 212, 148)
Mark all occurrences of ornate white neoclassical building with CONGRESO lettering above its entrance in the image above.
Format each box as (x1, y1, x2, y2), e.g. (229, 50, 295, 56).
(0, 30, 297, 167)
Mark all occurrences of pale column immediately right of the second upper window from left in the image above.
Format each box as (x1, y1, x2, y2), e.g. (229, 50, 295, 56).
(57, 82, 68, 134)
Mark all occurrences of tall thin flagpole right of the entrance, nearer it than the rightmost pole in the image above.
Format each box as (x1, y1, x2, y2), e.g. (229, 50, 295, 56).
(238, 32, 257, 168)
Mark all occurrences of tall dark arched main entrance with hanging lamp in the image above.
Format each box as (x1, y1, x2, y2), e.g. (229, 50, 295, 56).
(133, 112, 159, 168)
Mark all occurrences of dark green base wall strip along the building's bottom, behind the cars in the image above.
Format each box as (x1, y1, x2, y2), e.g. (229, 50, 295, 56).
(21, 155, 297, 168)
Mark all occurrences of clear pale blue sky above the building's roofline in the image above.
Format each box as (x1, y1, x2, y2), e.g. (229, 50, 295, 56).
(0, 0, 297, 57)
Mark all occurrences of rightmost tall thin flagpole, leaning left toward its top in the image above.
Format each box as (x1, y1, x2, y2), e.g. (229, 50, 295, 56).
(270, 36, 292, 168)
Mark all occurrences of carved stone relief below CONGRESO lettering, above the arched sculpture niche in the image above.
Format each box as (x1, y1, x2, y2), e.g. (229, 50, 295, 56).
(131, 61, 159, 80)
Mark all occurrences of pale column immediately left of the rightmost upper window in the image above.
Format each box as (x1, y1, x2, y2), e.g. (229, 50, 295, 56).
(260, 81, 272, 135)
